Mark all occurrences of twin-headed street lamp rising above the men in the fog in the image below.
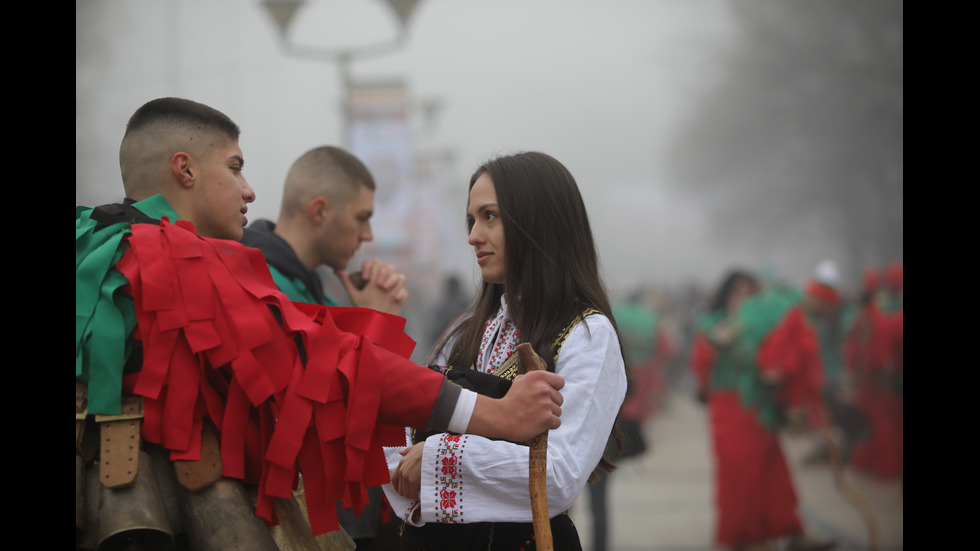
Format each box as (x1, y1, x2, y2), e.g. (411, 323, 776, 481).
(262, 0, 421, 147)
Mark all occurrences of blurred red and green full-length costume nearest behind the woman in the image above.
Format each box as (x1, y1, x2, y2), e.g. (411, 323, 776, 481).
(691, 291, 823, 547)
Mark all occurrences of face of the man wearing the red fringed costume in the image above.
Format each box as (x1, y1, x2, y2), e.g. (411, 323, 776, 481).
(188, 140, 255, 240)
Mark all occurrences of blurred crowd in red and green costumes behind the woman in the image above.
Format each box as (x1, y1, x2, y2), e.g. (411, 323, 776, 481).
(568, 260, 904, 551)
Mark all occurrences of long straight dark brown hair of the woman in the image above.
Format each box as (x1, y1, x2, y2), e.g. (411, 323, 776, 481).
(435, 152, 625, 481)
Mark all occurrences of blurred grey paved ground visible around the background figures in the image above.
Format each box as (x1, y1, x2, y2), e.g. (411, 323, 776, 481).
(571, 392, 903, 551)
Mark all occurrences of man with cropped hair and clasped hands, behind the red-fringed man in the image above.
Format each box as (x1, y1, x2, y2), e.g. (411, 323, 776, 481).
(242, 146, 418, 549)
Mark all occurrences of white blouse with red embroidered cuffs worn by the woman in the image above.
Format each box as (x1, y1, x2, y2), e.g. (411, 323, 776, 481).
(384, 299, 626, 526)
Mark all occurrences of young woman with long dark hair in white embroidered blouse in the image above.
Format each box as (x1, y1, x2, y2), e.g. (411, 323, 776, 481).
(389, 152, 627, 550)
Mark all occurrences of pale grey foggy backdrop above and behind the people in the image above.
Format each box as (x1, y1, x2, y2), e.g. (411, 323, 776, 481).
(75, 0, 904, 362)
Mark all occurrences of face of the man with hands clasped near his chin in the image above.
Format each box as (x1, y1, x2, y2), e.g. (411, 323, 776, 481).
(317, 186, 374, 270)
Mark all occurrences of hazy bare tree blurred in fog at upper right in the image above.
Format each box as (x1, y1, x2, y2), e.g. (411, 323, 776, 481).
(673, 0, 903, 284)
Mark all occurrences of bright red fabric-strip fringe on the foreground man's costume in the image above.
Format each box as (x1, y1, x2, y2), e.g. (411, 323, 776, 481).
(116, 220, 443, 534)
